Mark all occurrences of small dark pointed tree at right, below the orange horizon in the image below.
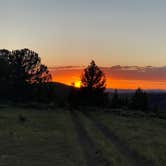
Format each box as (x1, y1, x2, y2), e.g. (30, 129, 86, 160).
(131, 88, 148, 111)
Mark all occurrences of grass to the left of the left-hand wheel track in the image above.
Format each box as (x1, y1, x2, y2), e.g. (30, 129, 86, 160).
(0, 108, 85, 166)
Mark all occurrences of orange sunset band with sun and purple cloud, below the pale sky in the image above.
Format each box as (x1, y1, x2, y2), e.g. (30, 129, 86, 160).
(50, 65, 166, 90)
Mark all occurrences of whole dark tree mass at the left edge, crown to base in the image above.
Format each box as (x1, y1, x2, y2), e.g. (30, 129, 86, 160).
(0, 49, 51, 100)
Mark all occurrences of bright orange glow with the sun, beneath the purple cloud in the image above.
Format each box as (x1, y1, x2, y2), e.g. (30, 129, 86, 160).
(51, 69, 166, 90)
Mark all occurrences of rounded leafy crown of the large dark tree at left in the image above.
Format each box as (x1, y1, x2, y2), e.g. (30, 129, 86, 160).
(9, 49, 51, 85)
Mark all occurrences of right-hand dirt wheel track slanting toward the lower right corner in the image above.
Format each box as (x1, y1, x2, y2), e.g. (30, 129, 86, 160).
(83, 113, 154, 166)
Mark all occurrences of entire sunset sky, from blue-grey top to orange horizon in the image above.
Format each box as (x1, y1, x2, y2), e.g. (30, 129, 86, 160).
(0, 0, 166, 89)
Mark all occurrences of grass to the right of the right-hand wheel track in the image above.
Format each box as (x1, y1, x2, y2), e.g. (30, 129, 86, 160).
(93, 110, 166, 166)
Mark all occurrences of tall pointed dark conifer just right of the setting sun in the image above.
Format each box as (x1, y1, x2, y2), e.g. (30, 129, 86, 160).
(79, 60, 107, 105)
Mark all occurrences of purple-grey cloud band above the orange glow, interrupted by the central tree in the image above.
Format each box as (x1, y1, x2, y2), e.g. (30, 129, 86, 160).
(49, 65, 166, 81)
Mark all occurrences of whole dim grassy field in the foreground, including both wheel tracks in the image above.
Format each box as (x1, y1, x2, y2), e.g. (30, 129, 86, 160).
(0, 106, 166, 166)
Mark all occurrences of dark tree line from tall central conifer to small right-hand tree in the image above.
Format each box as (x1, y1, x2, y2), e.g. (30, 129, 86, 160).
(68, 60, 149, 111)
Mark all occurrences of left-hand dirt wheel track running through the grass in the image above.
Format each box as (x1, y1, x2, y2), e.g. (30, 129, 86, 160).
(71, 111, 111, 166)
